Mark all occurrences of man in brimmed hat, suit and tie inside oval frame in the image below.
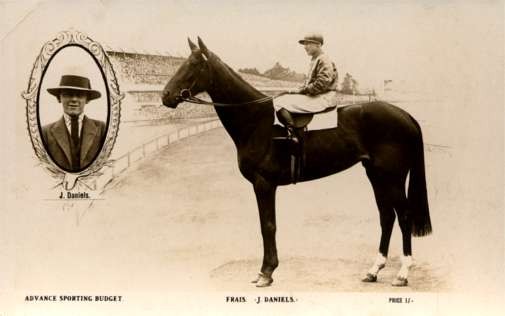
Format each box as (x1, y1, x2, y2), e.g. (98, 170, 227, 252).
(42, 74, 106, 172)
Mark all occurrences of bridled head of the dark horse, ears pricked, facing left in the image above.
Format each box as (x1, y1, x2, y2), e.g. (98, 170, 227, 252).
(162, 37, 211, 108)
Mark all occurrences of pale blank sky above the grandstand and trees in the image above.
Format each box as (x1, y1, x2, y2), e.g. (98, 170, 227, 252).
(0, 0, 504, 90)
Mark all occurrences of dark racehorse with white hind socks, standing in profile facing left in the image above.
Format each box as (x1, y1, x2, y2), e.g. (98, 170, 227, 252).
(161, 37, 432, 287)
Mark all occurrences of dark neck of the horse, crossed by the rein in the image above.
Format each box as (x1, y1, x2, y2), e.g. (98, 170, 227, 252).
(207, 65, 274, 152)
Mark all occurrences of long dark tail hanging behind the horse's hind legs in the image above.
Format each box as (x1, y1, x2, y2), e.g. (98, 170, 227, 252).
(407, 117, 432, 236)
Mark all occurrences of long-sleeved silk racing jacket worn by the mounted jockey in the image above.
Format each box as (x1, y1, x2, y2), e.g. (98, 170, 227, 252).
(300, 53, 338, 95)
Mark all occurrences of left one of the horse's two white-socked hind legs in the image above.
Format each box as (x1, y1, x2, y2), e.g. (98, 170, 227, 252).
(362, 169, 395, 282)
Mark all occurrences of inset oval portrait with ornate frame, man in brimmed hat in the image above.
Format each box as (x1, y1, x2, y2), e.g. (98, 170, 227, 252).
(23, 31, 123, 189)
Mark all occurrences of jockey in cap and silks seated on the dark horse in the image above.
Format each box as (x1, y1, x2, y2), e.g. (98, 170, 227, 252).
(274, 34, 338, 141)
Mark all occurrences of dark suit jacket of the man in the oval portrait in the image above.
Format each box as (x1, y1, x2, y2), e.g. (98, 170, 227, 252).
(42, 116, 107, 172)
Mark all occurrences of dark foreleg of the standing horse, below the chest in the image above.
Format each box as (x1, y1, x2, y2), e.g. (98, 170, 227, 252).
(253, 179, 279, 287)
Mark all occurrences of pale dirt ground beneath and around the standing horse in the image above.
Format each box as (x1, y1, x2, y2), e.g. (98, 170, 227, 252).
(6, 106, 504, 296)
